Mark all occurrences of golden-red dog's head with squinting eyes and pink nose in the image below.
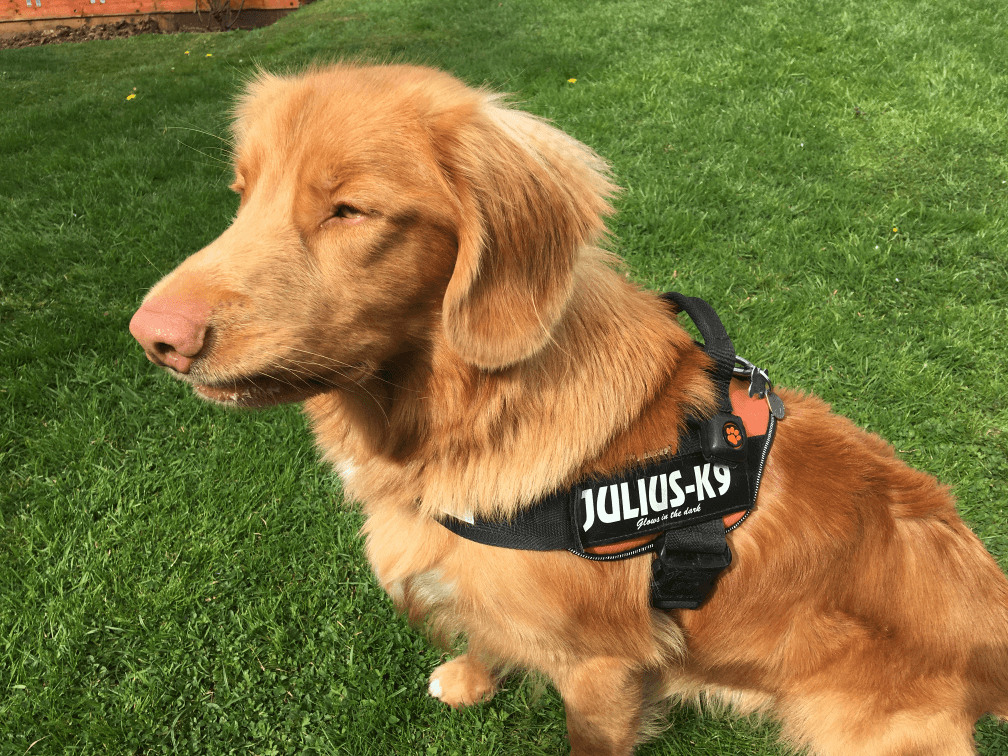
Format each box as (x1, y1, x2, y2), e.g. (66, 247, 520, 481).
(130, 66, 613, 406)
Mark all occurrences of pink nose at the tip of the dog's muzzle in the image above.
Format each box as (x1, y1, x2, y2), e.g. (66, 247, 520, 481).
(129, 296, 210, 373)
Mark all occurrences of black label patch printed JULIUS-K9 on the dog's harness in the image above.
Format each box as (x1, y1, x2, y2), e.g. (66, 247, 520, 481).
(573, 453, 750, 547)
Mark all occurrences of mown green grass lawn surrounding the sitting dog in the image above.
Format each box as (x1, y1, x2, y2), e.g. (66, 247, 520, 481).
(0, 0, 1008, 756)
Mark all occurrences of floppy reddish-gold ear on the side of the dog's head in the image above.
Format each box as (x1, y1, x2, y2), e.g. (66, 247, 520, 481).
(432, 93, 616, 370)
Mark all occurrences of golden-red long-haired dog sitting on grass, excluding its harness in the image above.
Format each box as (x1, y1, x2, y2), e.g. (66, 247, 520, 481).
(130, 65, 1008, 756)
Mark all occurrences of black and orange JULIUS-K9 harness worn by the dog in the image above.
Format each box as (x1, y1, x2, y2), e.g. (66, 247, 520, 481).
(440, 291, 784, 610)
